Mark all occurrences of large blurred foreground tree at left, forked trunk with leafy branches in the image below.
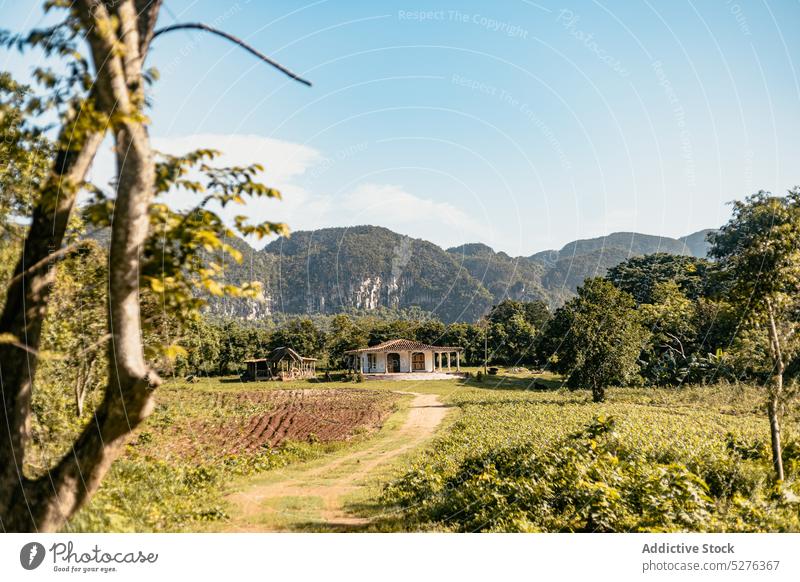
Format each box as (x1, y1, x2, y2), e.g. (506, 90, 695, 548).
(0, 0, 310, 531)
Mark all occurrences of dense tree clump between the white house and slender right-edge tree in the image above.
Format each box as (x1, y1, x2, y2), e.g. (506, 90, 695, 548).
(537, 253, 740, 394)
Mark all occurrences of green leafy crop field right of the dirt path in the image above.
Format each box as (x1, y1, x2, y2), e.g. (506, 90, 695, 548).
(382, 381, 800, 531)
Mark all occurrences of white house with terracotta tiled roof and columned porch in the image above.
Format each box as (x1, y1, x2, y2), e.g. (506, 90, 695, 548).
(346, 339, 464, 379)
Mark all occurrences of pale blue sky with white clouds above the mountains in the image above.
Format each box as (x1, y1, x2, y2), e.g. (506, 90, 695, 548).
(0, 0, 800, 255)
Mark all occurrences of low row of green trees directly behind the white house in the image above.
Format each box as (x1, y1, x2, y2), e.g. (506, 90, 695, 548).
(165, 300, 550, 375)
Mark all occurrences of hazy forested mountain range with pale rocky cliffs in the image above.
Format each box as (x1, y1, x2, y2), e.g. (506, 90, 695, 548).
(209, 226, 711, 322)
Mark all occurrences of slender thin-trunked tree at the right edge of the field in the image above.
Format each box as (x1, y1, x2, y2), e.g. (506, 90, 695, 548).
(710, 188, 800, 481)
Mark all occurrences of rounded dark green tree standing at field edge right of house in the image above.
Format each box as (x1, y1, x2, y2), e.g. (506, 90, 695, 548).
(542, 278, 648, 402)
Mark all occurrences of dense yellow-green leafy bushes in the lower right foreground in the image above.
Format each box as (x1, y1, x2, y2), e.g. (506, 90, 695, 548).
(384, 404, 800, 532)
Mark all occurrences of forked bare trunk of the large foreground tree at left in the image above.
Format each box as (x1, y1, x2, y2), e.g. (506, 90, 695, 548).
(0, 0, 160, 531)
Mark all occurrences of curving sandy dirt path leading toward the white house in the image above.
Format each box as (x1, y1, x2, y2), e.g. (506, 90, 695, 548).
(223, 392, 448, 532)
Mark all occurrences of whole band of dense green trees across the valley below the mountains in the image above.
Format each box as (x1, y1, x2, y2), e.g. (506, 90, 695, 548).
(6, 193, 800, 492)
